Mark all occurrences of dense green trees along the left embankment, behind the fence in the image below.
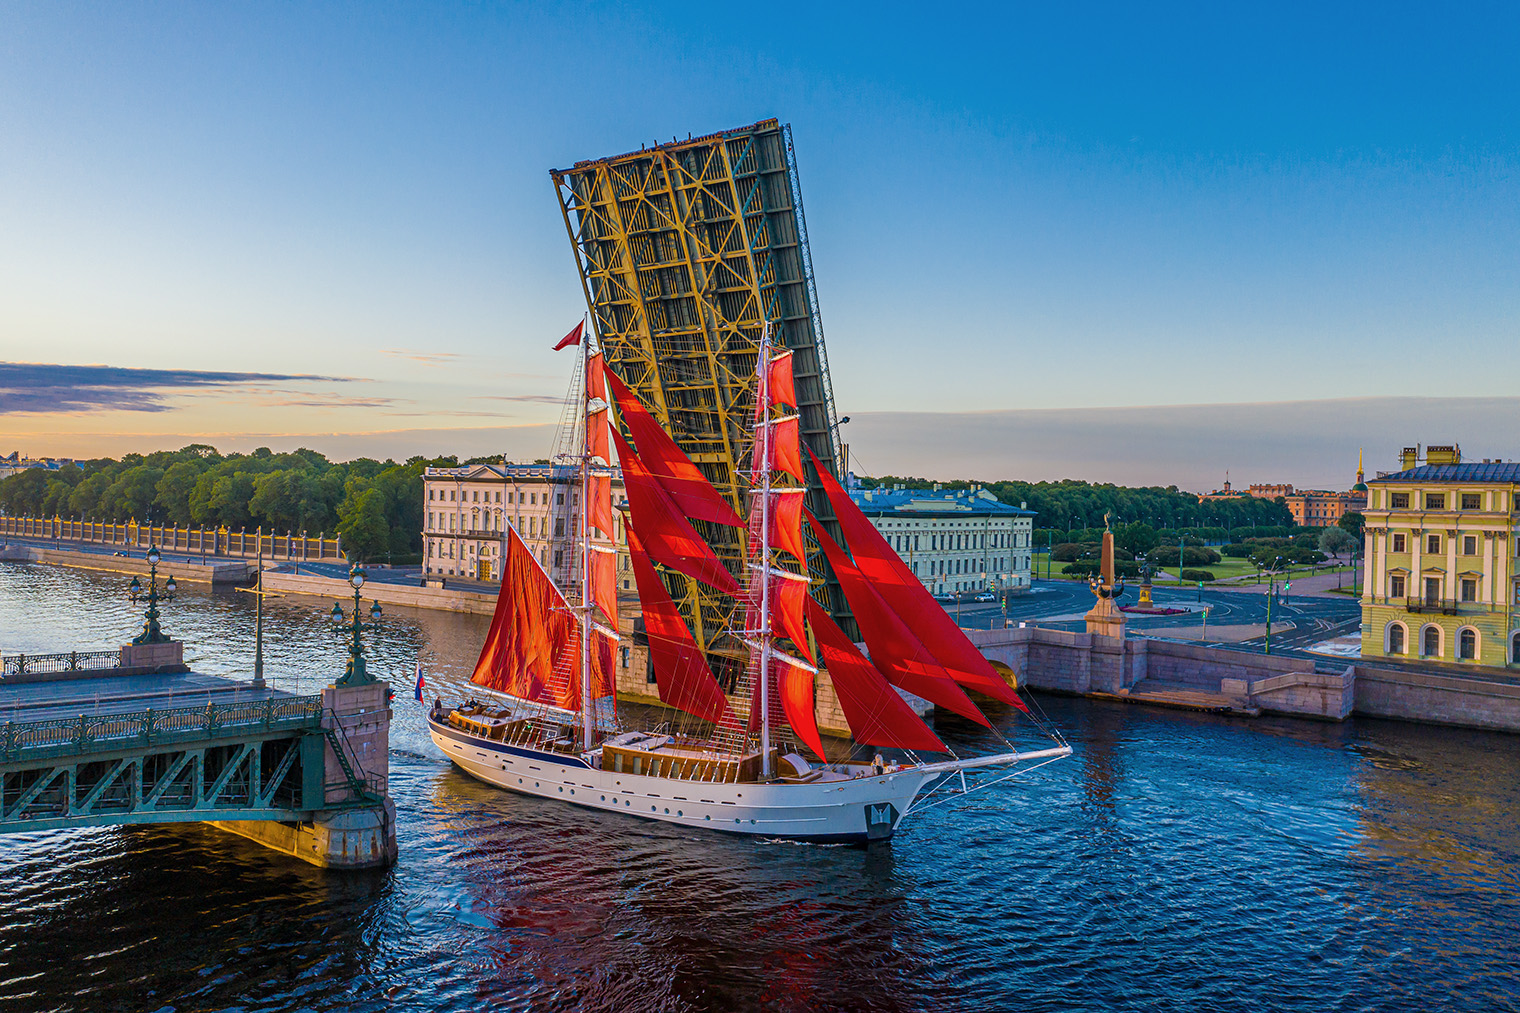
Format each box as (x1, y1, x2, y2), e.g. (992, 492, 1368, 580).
(0, 443, 500, 563)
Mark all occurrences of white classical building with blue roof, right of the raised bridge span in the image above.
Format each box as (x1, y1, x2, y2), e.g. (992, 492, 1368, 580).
(847, 476, 1035, 595)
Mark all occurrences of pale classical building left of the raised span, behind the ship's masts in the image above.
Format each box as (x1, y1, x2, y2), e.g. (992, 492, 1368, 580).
(423, 464, 632, 590)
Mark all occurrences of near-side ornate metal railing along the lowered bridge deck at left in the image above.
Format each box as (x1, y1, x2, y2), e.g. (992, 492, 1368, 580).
(0, 695, 322, 762)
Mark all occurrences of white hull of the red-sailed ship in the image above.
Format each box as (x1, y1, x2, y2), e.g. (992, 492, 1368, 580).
(427, 708, 948, 843)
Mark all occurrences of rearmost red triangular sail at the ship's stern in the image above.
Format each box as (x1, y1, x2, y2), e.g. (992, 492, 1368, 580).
(471, 529, 581, 710)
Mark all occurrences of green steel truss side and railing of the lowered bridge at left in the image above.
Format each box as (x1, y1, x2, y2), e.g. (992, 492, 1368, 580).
(0, 690, 380, 834)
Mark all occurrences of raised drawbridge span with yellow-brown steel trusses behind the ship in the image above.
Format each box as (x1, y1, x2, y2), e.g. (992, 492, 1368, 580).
(550, 120, 853, 638)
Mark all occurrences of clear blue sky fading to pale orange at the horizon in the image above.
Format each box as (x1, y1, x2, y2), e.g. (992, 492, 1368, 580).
(0, 3, 1520, 485)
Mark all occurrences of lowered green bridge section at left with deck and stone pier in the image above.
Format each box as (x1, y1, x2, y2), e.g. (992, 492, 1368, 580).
(0, 643, 394, 867)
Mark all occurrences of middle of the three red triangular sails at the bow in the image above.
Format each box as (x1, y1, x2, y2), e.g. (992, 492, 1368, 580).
(809, 514, 991, 727)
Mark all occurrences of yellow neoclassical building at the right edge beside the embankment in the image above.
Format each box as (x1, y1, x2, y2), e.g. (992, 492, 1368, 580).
(1362, 446, 1520, 666)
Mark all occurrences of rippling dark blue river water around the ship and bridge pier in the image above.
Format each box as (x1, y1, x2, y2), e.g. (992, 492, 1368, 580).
(0, 564, 1520, 1013)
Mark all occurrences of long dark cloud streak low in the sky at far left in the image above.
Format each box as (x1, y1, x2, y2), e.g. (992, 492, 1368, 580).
(0, 362, 348, 414)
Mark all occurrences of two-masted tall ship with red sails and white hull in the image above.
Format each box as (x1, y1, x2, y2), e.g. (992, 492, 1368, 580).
(429, 324, 1072, 841)
